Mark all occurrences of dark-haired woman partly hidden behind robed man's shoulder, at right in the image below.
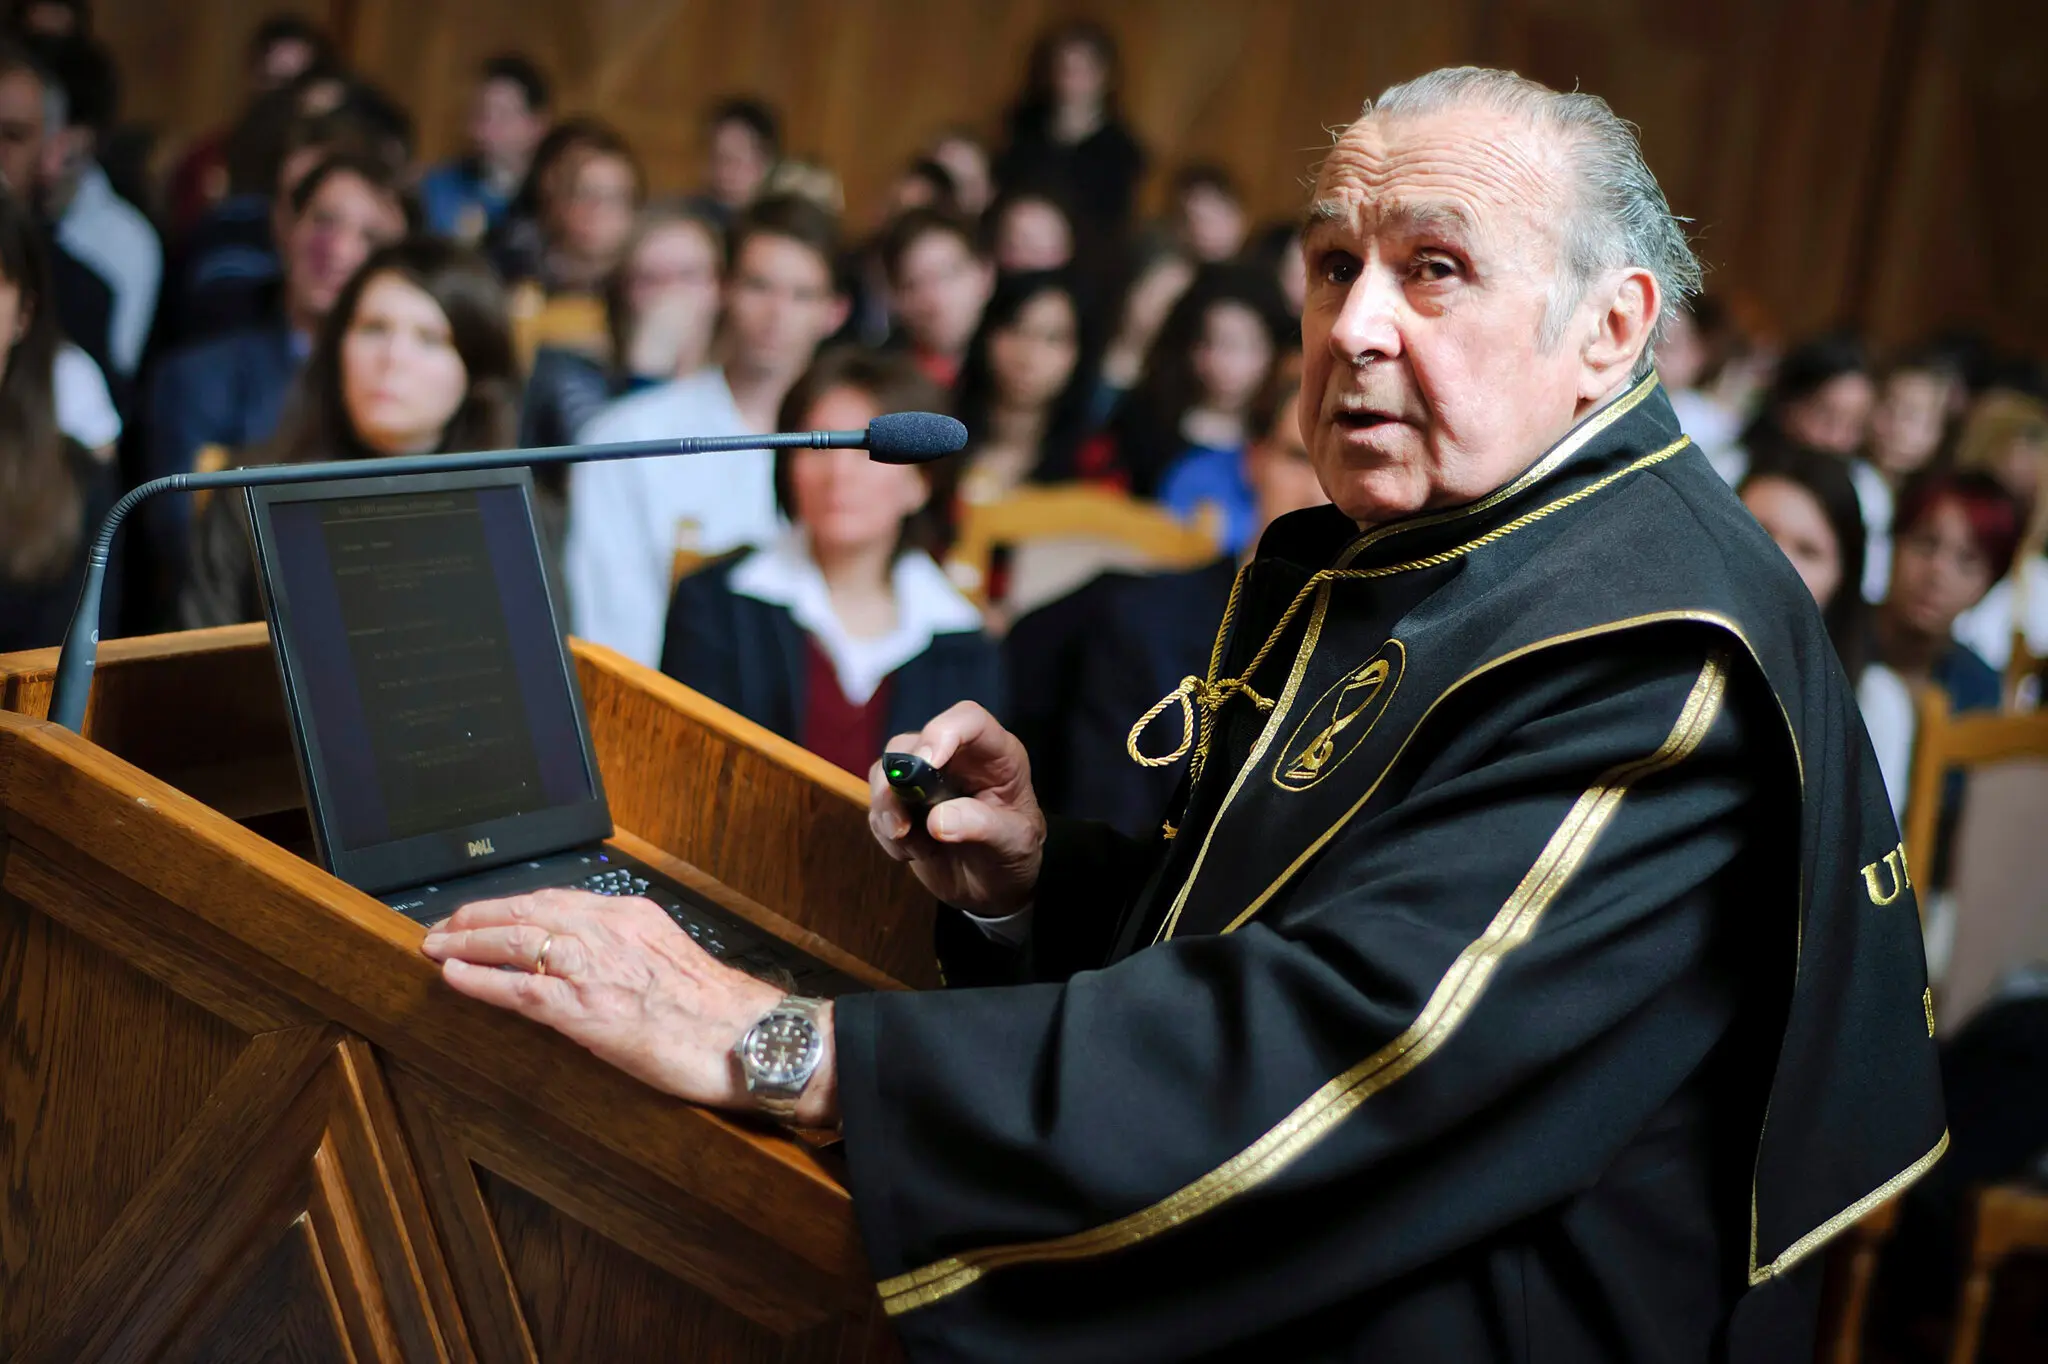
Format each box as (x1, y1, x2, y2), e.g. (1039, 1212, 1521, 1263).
(1741, 446, 1870, 678)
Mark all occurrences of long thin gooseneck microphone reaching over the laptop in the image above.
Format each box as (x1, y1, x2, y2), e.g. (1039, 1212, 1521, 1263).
(49, 412, 967, 733)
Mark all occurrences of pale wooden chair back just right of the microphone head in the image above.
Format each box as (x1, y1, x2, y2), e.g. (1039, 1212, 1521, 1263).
(950, 483, 1223, 606)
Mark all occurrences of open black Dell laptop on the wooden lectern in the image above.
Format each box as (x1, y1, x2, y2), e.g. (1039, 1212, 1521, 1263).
(246, 469, 864, 997)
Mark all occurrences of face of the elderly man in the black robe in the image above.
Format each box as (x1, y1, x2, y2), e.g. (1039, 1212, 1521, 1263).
(1300, 109, 1626, 524)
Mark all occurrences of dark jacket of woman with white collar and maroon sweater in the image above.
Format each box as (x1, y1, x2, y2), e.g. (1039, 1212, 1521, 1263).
(662, 549, 1004, 758)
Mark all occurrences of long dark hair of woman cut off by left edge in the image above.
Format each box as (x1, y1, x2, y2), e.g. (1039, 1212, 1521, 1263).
(0, 188, 72, 582)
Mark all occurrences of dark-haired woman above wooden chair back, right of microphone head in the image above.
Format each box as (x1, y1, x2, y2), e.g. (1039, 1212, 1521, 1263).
(952, 270, 1094, 502)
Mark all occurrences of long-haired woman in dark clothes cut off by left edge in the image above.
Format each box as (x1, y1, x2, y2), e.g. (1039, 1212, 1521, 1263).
(0, 188, 121, 653)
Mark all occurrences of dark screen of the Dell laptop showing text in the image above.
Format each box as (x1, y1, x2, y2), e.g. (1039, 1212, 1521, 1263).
(268, 487, 594, 850)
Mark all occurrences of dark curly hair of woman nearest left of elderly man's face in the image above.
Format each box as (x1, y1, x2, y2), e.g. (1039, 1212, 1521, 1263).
(1110, 262, 1294, 496)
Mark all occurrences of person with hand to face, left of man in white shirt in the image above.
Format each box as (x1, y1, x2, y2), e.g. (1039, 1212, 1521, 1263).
(518, 209, 725, 446)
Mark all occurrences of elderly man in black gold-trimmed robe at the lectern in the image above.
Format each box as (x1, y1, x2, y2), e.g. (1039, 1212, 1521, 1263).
(428, 70, 1946, 1362)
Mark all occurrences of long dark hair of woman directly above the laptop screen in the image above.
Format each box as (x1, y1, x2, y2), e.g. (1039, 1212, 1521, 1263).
(272, 238, 518, 463)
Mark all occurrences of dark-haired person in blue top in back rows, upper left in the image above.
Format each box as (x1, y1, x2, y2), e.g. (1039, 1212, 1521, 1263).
(420, 53, 549, 246)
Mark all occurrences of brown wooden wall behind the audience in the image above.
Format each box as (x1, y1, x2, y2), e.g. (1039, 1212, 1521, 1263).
(79, 0, 2048, 346)
